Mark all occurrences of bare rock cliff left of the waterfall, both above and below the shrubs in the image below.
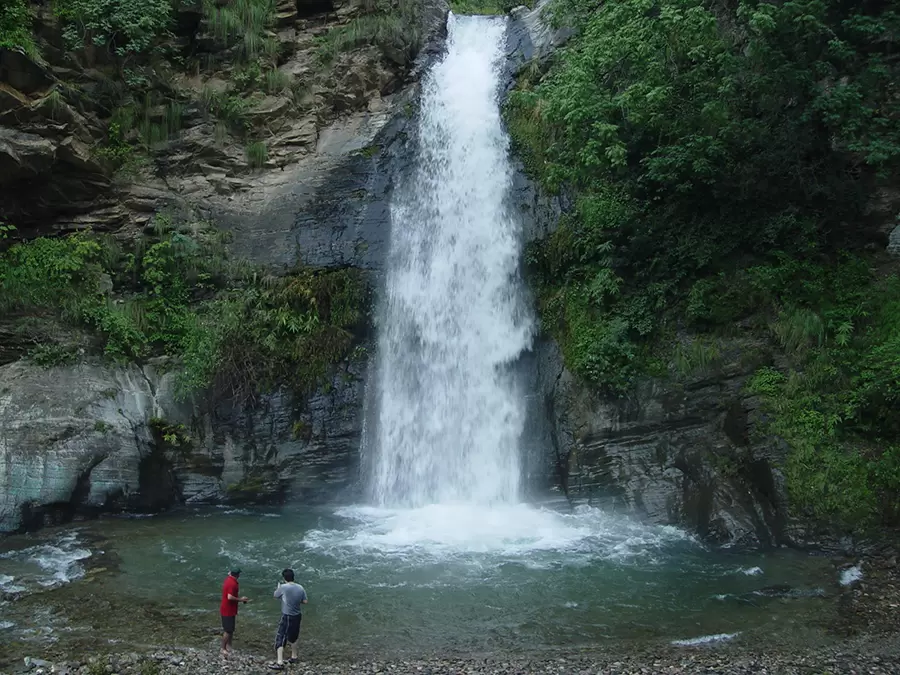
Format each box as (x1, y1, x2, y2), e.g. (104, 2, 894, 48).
(0, 0, 448, 532)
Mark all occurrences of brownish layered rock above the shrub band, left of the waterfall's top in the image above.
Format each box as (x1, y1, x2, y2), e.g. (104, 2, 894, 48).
(0, 0, 448, 240)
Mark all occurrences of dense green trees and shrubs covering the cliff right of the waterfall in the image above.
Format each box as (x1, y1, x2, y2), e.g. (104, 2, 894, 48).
(505, 0, 900, 527)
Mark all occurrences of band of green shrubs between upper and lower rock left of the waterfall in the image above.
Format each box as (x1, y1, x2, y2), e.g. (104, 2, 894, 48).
(0, 216, 367, 403)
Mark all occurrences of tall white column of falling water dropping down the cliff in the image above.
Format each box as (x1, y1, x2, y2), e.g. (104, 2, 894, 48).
(368, 14, 533, 507)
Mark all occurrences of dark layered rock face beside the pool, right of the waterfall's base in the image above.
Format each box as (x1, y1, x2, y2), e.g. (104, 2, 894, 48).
(537, 340, 803, 547)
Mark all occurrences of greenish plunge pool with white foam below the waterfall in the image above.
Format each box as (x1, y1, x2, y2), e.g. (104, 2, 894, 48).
(0, 505, 838, 654)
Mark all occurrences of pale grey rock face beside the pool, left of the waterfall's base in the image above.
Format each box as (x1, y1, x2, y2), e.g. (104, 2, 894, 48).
(0, 361, 364, 532)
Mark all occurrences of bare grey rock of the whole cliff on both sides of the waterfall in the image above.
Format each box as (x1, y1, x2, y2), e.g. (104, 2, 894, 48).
(0, 0, 836, 546)
